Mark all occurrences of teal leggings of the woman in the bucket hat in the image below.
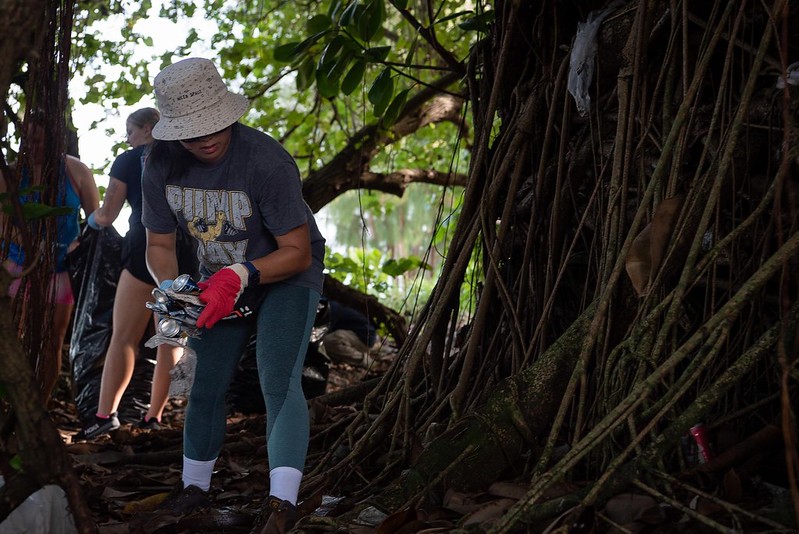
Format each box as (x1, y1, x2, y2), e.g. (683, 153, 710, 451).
(183, 283, 320, 471)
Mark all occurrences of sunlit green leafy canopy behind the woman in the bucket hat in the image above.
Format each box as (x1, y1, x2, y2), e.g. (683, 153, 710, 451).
(73, 0, 492, 308)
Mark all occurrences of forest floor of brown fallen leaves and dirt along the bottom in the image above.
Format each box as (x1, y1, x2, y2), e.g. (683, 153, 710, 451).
(25, 351, 796, 534)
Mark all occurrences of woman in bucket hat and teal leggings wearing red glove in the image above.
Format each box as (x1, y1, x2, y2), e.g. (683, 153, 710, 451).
(142, 58, 325, 532)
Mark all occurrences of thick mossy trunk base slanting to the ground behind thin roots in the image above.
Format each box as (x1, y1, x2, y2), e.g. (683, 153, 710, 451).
(378, 306, 595, 510)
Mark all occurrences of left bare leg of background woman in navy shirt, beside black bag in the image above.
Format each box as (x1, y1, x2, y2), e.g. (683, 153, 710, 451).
(97, 269, 153, 415)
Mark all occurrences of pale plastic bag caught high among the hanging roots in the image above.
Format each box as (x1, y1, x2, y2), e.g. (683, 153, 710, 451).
(567, 0, 623, 117)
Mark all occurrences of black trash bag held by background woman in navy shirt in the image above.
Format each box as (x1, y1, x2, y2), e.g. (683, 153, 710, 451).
(67, 227, 155, 423)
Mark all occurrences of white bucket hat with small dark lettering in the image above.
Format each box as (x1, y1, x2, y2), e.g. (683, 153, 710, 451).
(153, 58, 249, 141)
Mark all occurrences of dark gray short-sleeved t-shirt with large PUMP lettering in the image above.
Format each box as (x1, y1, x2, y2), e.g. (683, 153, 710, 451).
(142, 123, 325, 293)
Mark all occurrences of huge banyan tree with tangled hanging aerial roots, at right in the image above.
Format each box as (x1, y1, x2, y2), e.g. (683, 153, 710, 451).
(0, 0, 799, 532)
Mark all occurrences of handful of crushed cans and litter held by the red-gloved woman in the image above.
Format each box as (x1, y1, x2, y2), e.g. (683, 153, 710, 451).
(146, 274, 205, 346)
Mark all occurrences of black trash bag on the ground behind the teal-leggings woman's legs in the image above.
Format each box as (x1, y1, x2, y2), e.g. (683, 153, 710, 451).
(227, 335, 330, 414)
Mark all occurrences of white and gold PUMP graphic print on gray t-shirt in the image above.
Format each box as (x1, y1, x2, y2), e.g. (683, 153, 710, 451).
(167, 185, 252, 270)
